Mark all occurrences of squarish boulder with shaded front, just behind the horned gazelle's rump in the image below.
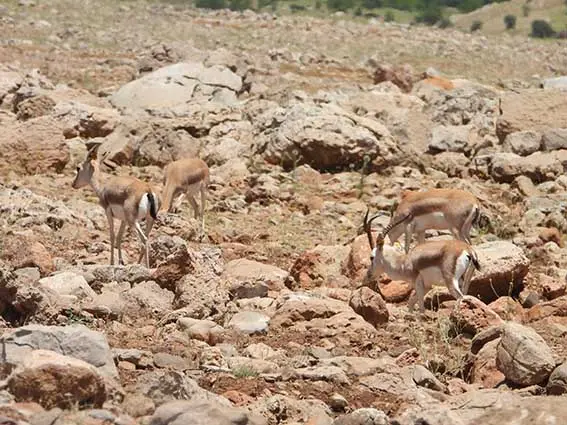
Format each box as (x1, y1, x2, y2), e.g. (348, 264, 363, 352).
(467, 241, 530, 304)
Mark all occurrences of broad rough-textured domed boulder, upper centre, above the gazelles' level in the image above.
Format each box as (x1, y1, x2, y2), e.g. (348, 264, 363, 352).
(257, 103, 403, 170)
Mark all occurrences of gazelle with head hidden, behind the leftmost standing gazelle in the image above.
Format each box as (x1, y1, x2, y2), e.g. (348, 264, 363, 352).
(162, 158, 209, 232)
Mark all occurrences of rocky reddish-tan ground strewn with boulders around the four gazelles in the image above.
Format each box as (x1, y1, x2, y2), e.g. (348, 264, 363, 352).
(0, 0, 567, 425)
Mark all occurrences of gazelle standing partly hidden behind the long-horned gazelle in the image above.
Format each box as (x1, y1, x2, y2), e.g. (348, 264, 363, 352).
(388, 189, 480, 253)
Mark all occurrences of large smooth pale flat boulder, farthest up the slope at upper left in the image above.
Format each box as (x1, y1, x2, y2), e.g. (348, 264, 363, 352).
(110, 62, 242, 110)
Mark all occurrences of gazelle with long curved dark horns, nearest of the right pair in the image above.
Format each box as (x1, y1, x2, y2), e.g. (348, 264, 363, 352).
(363, 210, 480, 314)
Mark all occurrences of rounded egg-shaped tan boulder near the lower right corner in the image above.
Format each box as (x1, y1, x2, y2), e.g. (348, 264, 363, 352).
(496, 322, 555, 386)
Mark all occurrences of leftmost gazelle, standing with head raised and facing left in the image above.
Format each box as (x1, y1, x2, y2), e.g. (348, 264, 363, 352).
(73, 145, 159, 268)
